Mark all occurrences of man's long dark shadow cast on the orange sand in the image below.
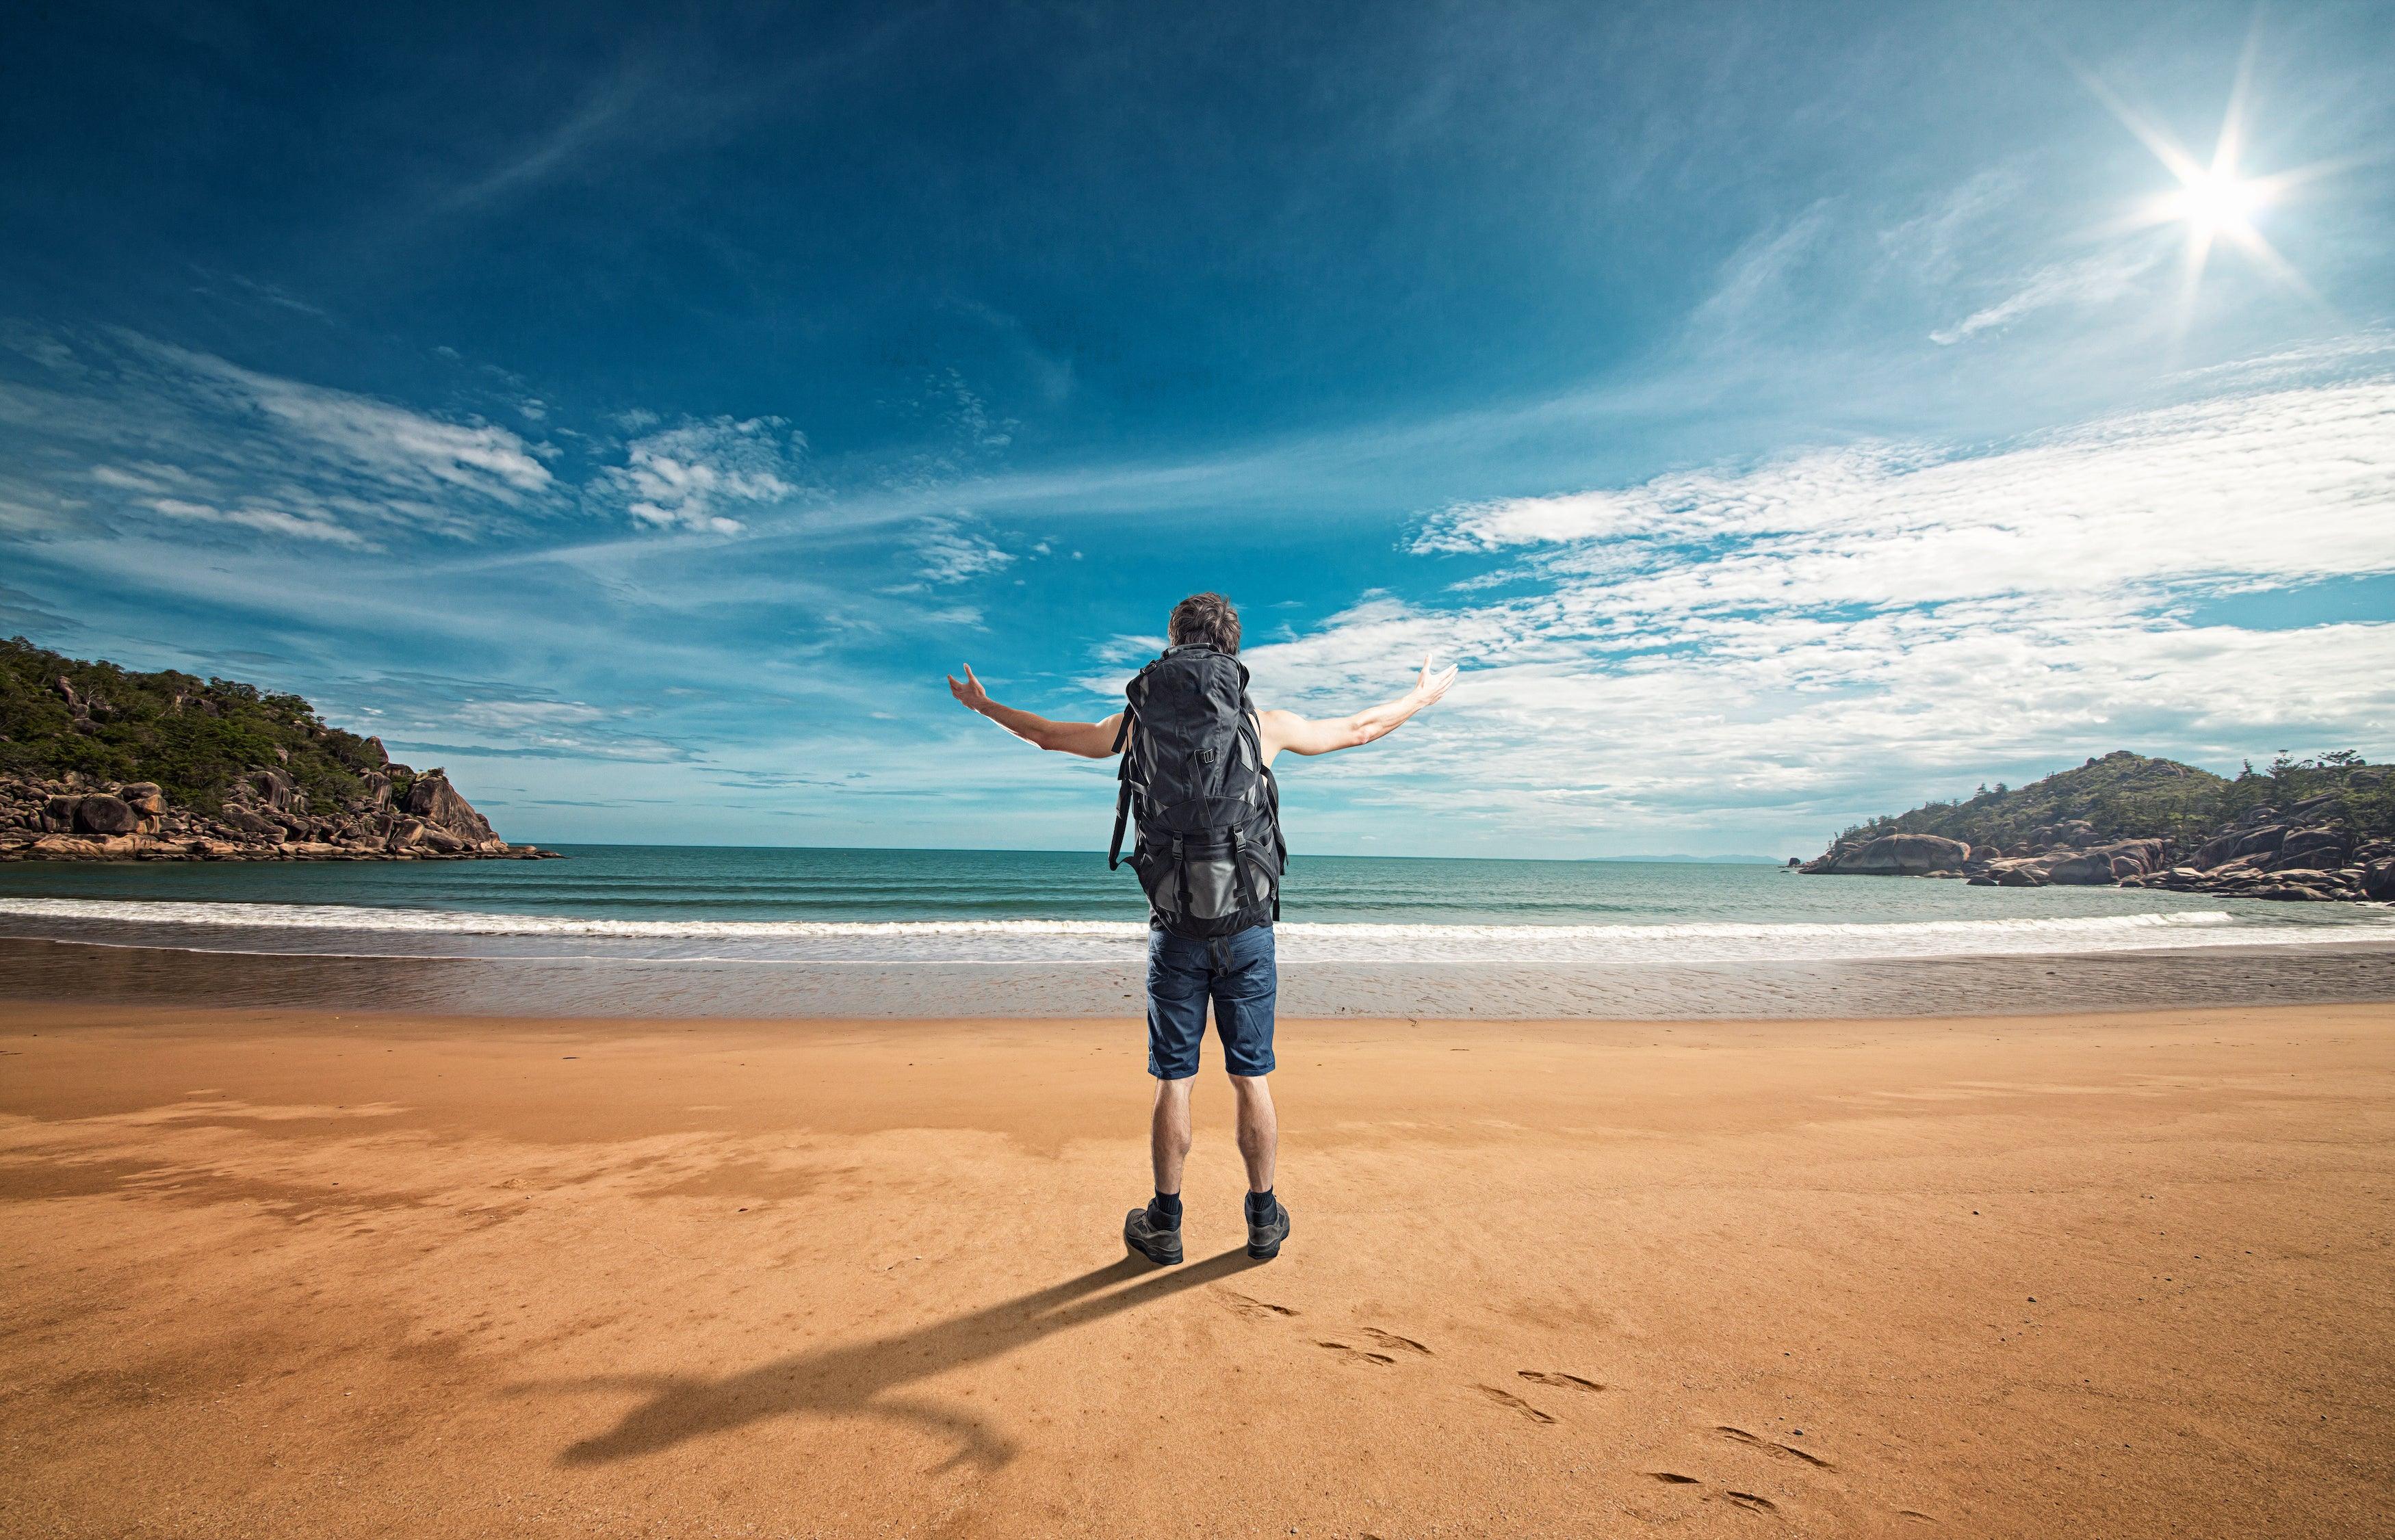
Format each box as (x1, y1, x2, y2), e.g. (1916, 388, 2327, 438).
(522, 1250, 1263, 1470)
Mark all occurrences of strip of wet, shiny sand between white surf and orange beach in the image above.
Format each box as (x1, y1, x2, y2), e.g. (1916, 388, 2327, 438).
(0, 937, 2395, 1020)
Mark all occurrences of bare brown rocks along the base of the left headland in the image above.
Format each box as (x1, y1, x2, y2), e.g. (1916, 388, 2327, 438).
(0, 771, 554, 860)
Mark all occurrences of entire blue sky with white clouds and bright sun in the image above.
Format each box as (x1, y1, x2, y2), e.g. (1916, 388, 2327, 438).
(0, 0, 2395, 857)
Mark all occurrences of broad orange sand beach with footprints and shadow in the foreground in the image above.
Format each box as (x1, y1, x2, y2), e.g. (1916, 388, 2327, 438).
(0, 1004, 2395, 1540)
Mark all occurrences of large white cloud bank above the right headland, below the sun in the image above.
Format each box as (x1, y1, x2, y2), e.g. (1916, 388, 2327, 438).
(1248, 376, 2395, 838)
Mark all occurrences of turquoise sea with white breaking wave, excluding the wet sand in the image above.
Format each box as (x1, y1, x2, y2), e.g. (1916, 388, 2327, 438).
(0, 846, 2395, 963)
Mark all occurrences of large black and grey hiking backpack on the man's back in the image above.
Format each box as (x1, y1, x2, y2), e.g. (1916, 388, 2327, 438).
(1106, 644, 1289, 941)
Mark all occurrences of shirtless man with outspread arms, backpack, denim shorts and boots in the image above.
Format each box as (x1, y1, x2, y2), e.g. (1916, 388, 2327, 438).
(948, 594, 1456, 1264)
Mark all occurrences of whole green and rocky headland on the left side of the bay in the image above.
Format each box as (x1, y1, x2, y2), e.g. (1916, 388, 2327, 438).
(0, 637, 554, 860)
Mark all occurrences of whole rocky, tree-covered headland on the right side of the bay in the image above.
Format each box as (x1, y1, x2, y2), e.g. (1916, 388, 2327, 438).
(1789, 750, 2395, 900)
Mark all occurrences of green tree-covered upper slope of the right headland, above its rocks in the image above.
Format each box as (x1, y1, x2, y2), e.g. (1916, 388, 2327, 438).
(1837, 750, 2395, 850)
